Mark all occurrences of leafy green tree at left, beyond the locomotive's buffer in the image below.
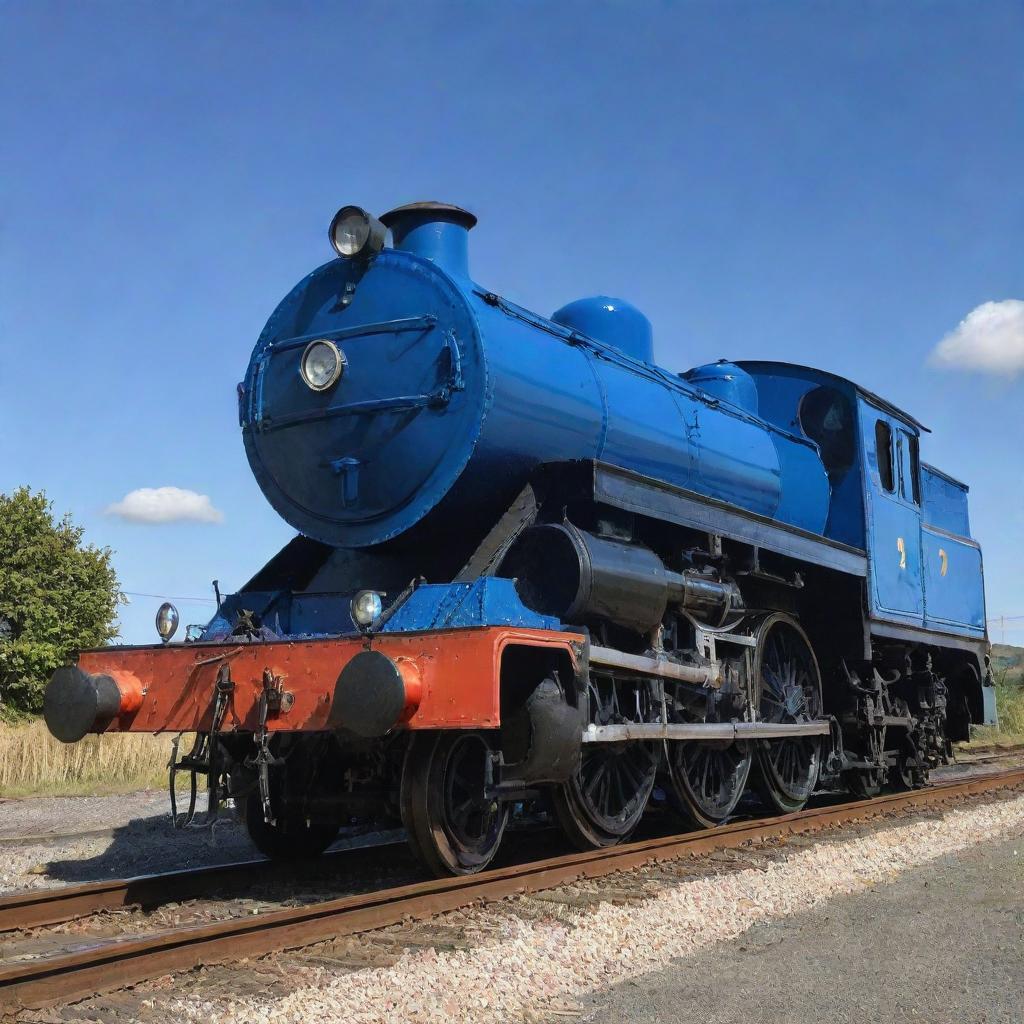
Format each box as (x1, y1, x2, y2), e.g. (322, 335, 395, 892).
(0, 487, 124, 714)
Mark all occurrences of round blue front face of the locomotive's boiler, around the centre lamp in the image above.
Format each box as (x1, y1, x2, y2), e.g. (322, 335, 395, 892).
(243, 250, 487, 547)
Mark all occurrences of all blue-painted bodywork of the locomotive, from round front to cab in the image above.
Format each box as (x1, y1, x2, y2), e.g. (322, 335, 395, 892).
(232, 208, 984, 636)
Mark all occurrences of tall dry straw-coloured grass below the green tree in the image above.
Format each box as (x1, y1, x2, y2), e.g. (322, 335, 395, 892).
(0, 721, 184, 797)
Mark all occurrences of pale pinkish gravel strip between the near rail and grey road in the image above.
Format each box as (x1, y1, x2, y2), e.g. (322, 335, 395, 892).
(145, 796, 1024, 1024)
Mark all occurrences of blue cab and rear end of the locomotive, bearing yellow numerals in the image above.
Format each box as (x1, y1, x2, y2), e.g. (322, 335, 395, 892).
(742, 361, 995, 738)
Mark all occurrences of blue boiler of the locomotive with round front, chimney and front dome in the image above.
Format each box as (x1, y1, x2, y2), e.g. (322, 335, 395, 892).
(240, 210, 828, 547)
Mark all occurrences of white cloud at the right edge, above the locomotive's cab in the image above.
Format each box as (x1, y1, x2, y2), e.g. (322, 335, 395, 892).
(929, 299, 1024, 377)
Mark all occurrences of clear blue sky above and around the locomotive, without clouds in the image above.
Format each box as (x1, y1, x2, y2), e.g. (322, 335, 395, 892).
(0, 0, 1024, 642)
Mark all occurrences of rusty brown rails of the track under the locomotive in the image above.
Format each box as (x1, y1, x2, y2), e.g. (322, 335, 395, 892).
(0, 768, 1024, 1014)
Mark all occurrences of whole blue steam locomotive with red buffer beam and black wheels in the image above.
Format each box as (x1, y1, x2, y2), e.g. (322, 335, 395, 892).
(45, 203, 994, 874)
